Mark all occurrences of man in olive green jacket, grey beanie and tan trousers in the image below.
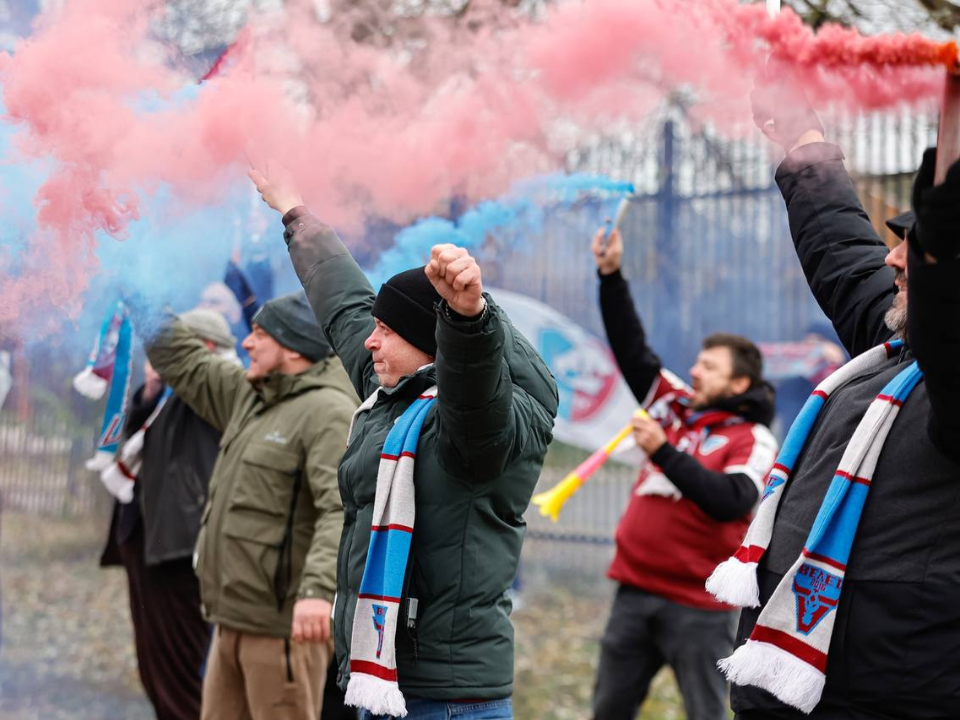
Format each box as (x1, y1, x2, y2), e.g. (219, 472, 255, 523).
(138, 293, 358, 720)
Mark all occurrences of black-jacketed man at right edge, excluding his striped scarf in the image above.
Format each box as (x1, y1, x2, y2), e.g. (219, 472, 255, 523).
(732, 98, 960, 720)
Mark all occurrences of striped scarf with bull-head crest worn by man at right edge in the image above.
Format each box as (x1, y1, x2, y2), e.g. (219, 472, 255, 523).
(707, 341, 922, 713)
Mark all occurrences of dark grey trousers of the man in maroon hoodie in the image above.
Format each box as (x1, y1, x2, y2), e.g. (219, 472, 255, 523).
(593, 585, 736, 720)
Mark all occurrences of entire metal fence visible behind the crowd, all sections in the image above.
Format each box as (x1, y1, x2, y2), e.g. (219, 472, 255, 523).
(0, 108, 936, 552)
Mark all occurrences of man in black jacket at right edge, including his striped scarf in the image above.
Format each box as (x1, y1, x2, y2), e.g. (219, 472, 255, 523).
(716, 78, 960, 720)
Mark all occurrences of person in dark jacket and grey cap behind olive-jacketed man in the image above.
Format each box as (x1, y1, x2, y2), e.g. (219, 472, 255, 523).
(100, 309, 239, 720)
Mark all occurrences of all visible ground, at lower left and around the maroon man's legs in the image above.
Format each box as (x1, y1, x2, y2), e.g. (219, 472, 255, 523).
(0, 512, 684, 720)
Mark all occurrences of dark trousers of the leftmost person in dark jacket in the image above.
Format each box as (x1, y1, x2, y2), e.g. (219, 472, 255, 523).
(119, 525, 210, 720)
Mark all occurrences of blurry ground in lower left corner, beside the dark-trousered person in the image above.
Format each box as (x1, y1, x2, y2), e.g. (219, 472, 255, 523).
(0, 513, 153, 720)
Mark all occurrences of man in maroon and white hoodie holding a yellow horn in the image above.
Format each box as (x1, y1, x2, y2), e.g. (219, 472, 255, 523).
(593, 229, 777, 720)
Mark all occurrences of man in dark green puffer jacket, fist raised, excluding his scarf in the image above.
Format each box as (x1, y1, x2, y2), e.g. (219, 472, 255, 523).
(251, 171, 557, 720)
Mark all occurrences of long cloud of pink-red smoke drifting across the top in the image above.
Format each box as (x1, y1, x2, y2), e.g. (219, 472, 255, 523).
(0, 0, 956, 332)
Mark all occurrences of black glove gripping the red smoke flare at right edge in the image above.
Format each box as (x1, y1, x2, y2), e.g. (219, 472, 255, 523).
(910, 148, 960, 260)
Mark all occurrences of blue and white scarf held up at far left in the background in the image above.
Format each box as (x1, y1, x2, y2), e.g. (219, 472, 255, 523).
(73, 300, 133, 472)
